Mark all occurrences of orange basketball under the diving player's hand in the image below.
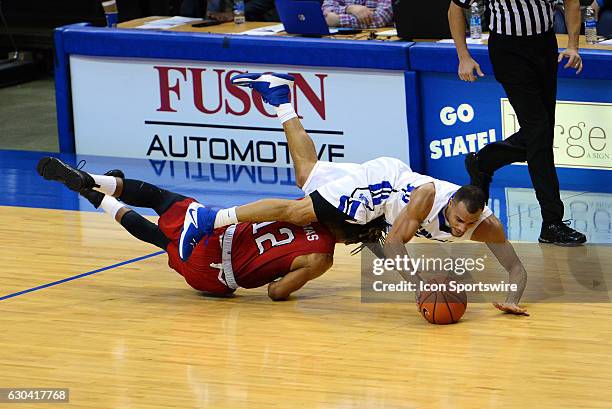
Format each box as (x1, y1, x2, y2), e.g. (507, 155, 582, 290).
(419, 277, 467, 325)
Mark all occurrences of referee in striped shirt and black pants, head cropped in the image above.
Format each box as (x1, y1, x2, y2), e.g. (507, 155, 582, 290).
(448, 0, 586, 245)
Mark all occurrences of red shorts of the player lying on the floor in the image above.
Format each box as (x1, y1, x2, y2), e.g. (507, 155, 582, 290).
(157, 198, 234, 294)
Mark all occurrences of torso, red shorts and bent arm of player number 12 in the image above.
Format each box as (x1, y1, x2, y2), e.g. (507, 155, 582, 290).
(158, 194, 336, 300)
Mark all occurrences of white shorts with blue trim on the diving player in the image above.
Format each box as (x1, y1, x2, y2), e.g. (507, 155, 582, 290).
(302, 157, 412, 224)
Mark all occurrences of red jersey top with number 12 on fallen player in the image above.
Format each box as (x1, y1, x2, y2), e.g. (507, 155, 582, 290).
(231, 222, 336, 288)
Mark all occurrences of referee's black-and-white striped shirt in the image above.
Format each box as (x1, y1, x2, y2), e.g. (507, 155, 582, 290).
(453, 0, 555, 36)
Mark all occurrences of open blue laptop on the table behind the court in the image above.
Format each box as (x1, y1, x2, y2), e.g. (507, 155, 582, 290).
(276, 0, 331, 36)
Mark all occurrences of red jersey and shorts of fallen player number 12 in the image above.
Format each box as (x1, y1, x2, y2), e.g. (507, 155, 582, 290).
(158, 198, 335, 294)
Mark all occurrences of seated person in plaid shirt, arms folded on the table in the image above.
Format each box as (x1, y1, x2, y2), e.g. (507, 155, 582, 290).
(323, 0, 393, 28)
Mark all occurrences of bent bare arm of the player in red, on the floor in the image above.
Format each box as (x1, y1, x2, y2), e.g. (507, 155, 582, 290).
(268, 253, 333, 301)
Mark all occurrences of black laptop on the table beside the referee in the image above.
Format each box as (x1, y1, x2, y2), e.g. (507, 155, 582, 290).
(393, 0, 451, 41)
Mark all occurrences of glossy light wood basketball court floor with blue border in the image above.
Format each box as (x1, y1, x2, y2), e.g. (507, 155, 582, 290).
(0, 151, 612, 409)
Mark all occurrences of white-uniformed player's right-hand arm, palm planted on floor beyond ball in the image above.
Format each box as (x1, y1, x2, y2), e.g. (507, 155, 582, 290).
(472, 214, 529, 315)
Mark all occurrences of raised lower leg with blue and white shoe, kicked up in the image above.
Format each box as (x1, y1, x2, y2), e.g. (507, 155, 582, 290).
(231, 73, 318, 187)
